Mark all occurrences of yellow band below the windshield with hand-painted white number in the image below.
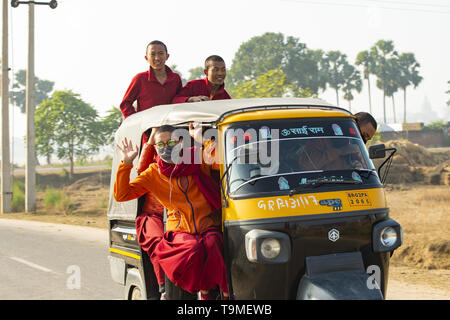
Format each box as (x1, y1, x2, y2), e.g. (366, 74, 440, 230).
(222, 188, 386, 221)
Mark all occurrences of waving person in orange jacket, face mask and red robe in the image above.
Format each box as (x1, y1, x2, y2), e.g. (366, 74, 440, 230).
(114, 126, 228, 300)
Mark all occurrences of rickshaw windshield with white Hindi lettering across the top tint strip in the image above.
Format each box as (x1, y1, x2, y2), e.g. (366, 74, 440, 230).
(225, 118, 379, 196)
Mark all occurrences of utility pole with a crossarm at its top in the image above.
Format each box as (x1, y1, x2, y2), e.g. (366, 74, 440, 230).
(11, 0, 57, 212)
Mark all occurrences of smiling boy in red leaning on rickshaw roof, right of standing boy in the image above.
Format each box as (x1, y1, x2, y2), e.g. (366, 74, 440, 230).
(172, 55, 231, 103)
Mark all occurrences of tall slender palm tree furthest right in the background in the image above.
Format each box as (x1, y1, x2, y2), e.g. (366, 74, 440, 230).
(398, 53, 423, 123)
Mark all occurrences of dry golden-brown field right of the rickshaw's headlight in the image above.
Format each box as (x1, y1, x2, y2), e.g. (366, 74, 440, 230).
(386, 186, 450, 269)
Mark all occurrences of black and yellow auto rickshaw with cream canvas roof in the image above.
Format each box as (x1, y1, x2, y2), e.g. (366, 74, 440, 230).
(108, 98, 403, 300)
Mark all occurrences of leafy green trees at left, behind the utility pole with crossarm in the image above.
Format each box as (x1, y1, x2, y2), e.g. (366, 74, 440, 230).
(10, 70, 123, 178)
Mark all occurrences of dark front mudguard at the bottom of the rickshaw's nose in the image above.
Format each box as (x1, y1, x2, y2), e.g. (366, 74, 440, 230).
(297, 252, 383, 300)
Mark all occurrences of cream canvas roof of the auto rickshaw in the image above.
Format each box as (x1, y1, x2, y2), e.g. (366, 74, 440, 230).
(117, 98, 351, 136)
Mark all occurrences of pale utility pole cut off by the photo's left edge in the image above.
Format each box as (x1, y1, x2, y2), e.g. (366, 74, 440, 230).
(0, 0, 12, 214)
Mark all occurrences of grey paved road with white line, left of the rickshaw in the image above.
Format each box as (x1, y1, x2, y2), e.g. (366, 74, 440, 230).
(0, 219, 123, 300)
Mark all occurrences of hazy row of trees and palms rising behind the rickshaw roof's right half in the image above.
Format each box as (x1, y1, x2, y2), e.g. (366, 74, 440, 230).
(223, 32, 423, 122)
